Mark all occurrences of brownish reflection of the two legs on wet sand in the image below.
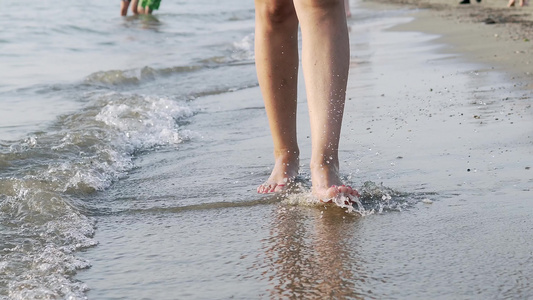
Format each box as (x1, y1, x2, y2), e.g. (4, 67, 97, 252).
(260, 206, 374, 299)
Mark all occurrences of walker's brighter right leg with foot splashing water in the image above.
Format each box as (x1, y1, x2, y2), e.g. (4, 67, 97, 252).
(295, 0, 357, 201)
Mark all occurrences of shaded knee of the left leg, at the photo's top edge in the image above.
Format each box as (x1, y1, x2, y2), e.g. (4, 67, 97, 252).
(255, 0, 297, 26)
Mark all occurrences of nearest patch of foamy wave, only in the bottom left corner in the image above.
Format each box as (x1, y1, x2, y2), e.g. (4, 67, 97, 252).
(0, 183, 97, 299)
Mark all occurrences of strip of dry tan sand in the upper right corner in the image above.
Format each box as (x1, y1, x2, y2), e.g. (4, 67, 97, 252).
(363, 0, 533, 89)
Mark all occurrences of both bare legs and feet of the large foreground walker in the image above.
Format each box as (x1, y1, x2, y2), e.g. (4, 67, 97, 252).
(255, 0, 358, 202)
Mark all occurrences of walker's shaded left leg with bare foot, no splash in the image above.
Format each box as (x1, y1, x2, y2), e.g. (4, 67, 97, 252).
(255, 0, 299, 193)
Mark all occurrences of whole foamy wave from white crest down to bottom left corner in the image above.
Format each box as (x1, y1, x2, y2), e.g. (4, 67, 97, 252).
(0, 93, 194, 299)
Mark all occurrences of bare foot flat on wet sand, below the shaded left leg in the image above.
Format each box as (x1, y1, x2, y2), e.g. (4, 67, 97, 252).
(257, 155, 299, 194)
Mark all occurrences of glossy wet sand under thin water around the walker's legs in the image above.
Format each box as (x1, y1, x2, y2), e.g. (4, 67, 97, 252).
(76, 3, 533, 299)
